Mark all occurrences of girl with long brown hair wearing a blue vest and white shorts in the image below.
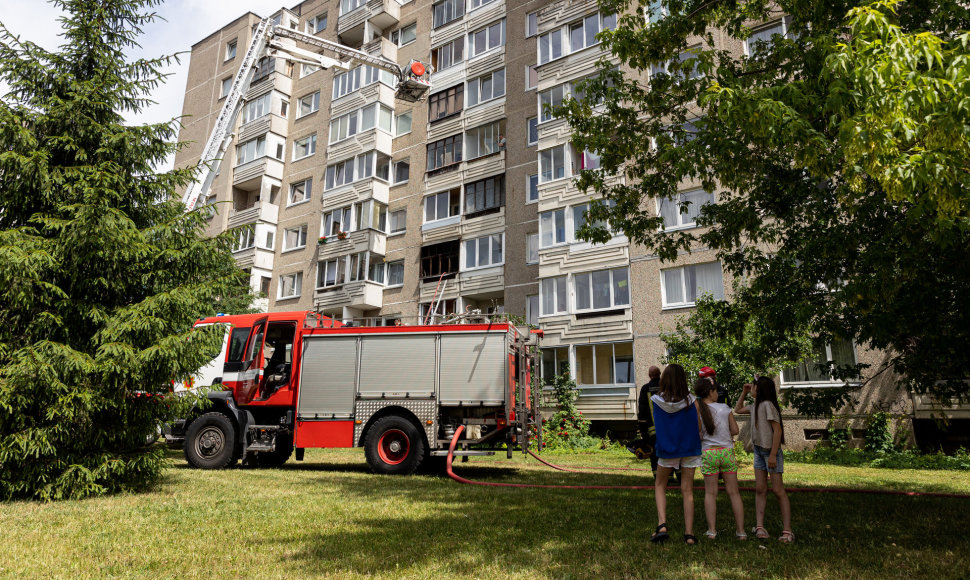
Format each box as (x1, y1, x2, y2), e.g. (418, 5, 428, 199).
(650, 364, 701, 546)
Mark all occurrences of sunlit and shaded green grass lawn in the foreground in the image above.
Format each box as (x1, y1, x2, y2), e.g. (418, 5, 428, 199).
(0, 450, 970, 578)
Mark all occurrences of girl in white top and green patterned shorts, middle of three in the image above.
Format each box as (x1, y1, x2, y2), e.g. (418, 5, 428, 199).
(694, 378, 748, 540)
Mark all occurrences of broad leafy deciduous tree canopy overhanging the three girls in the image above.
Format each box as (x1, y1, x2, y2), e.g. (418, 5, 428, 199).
(557, 0, 970, 406)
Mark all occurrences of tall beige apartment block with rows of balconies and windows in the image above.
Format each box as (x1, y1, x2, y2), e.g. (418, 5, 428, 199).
(176, 0, 936, 444)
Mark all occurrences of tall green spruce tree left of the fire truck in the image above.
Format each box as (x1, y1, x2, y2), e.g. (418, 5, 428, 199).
(0, 0, 246, 500)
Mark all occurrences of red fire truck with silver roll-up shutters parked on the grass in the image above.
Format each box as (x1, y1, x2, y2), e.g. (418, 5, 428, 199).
(165, 311, 539, 474)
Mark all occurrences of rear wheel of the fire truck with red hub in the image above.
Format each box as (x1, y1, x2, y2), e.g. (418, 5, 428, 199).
(364, 415, 426, 475)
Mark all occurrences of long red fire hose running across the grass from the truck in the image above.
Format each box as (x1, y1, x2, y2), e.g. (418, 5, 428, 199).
(445, 425, 970, 499)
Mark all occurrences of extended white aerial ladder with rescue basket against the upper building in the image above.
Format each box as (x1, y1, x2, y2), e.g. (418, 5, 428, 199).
(182, 18, 434, 211)
